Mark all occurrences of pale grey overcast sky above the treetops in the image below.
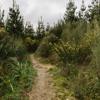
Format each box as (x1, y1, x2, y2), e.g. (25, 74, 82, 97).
(0, 0, 90, 27)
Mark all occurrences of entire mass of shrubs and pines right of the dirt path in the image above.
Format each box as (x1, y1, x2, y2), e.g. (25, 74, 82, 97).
(36, 1, 100, 100)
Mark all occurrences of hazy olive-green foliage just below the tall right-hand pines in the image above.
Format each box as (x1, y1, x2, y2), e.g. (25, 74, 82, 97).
(61, 20, 87, 44)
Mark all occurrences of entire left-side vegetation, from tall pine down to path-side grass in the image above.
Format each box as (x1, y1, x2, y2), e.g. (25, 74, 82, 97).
(0, 1, 36, 100)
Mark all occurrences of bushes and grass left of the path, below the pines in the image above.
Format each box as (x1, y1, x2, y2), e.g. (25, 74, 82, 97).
(0, 24, 36, 100)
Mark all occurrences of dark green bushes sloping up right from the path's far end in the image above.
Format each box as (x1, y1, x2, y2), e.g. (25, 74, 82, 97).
(36, 21, 64, 60)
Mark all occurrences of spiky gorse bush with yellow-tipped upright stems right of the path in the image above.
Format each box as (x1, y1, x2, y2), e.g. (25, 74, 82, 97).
(54, 41, 77, 65)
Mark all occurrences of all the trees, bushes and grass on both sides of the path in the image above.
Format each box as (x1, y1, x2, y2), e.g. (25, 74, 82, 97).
(0, 0, 100, 100)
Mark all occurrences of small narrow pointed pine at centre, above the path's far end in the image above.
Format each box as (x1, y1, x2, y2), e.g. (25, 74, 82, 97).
(36, 17, 45, 39)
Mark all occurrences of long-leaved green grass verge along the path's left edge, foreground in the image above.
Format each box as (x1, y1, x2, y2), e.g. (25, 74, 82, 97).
(0, 61, 37, 100)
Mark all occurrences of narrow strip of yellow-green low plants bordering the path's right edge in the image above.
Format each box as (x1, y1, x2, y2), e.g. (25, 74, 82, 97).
(50, 67, 76, 100)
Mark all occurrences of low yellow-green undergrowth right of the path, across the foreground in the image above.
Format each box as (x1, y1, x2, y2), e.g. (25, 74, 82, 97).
(50, 63, 100, 100)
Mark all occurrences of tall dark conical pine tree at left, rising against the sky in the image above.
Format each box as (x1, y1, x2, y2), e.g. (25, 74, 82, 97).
(6, 0, 24, 37)
